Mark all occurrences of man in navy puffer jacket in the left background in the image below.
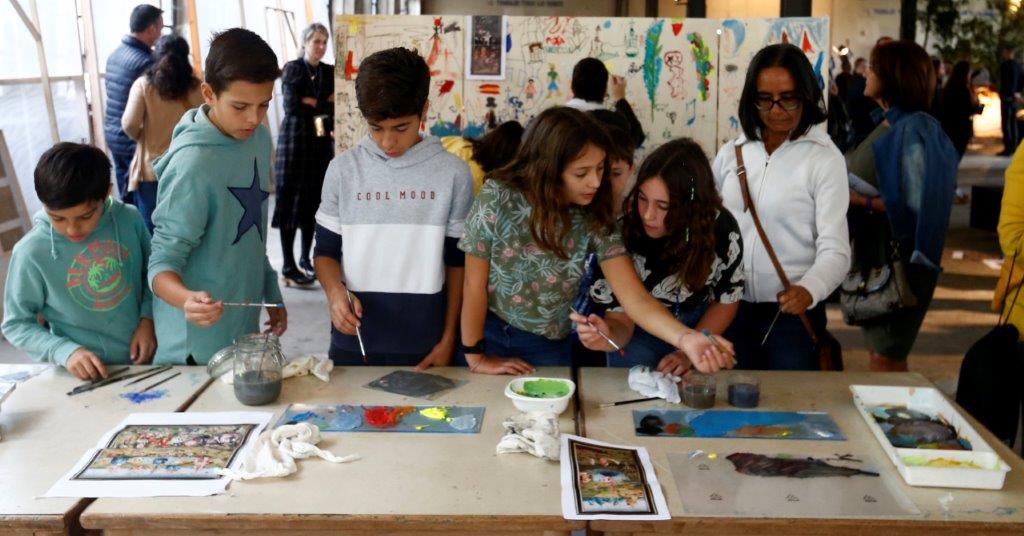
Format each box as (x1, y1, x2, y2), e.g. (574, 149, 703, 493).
(103, 4, 164, 203)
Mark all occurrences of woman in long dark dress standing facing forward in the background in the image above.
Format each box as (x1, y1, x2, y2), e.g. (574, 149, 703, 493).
(270, 23, 334, 288)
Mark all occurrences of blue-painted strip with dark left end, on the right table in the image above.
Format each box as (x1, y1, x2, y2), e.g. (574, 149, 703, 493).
(633, 409, 846, 441)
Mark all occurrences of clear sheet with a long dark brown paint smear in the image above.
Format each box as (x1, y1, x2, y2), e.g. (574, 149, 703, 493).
(668, 451, 920, 518)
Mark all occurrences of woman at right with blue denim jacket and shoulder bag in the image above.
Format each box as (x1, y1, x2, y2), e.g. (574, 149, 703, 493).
(841, 41, 959, 372)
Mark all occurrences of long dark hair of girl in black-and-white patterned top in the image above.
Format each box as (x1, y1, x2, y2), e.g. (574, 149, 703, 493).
(623, 137, 723, 292)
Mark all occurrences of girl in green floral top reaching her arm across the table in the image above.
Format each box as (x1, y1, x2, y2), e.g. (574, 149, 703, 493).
(459, 108, 732, 374)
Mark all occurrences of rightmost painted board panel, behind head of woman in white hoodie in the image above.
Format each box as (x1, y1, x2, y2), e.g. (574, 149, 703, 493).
(717, 17, 829, 147)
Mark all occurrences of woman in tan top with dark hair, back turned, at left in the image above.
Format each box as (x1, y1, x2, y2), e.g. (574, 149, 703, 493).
(121, 34, 203, 233)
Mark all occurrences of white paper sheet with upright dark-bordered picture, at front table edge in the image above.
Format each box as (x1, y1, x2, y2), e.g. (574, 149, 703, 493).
(561, 435, 670, 520)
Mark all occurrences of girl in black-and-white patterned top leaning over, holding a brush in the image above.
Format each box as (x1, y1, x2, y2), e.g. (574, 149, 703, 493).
(572, 138, 743, 375)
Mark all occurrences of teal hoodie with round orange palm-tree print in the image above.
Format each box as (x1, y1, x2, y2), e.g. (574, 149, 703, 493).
(3, 199, 153, 366)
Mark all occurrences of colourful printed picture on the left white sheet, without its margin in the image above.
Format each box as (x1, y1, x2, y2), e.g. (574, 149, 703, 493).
(74, 424, 255, 480)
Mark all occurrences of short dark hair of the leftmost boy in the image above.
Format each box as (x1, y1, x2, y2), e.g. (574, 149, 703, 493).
(33, 141, 111, 210)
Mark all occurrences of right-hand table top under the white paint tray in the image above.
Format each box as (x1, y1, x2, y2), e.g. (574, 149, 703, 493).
(580, 368, 1024, 534)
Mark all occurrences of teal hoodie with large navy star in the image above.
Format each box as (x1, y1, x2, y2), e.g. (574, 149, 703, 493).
(150, 106, 282, 364)
